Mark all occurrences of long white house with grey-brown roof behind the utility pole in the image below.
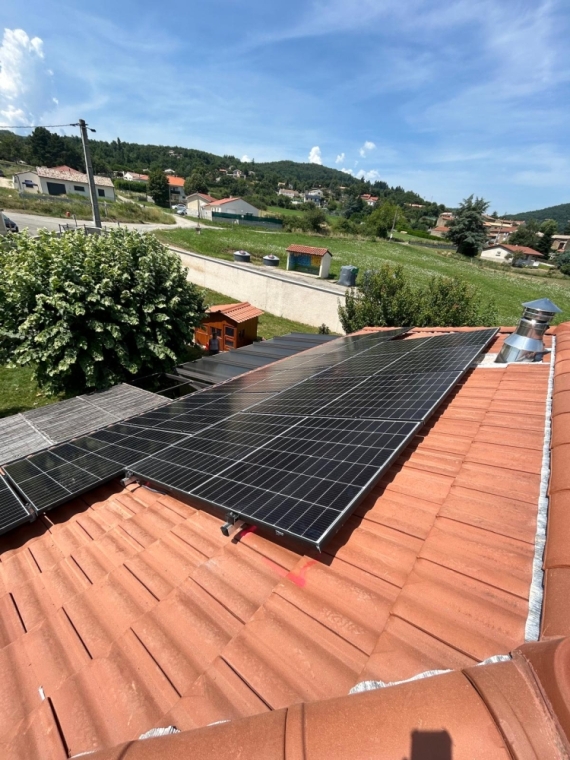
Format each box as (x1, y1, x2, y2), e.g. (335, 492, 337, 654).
(13, 166, 115, 200)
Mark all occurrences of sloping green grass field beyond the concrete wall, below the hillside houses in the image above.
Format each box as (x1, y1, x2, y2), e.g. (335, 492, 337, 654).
(157, 227, 570, 325)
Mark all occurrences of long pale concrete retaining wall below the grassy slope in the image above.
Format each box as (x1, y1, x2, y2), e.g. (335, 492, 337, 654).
(171, 248, 345, 333)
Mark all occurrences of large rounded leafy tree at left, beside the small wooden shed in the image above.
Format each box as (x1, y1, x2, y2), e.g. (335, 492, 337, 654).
(0, 229, 204, 393)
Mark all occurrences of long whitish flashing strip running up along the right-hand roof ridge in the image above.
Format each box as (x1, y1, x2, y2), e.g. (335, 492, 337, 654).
(524, 336, 556, 641)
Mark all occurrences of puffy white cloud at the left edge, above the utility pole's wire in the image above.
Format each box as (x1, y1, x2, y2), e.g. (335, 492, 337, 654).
(0, 29, 54, 124)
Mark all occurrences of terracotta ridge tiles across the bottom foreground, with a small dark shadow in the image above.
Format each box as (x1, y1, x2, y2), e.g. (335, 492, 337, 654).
(85, 640, 570, 760)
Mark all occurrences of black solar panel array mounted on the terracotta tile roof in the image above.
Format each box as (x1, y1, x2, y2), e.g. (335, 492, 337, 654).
(2, 330, 496, 548)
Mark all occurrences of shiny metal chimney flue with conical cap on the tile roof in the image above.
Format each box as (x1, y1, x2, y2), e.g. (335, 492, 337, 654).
(495, 298, 562, 364)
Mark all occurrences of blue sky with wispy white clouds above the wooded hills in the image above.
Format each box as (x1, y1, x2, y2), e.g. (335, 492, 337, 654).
(0, 0, 570, 213)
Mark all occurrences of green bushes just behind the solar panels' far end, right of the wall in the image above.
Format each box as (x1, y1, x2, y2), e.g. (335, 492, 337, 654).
(339, 264, 497, 333)
